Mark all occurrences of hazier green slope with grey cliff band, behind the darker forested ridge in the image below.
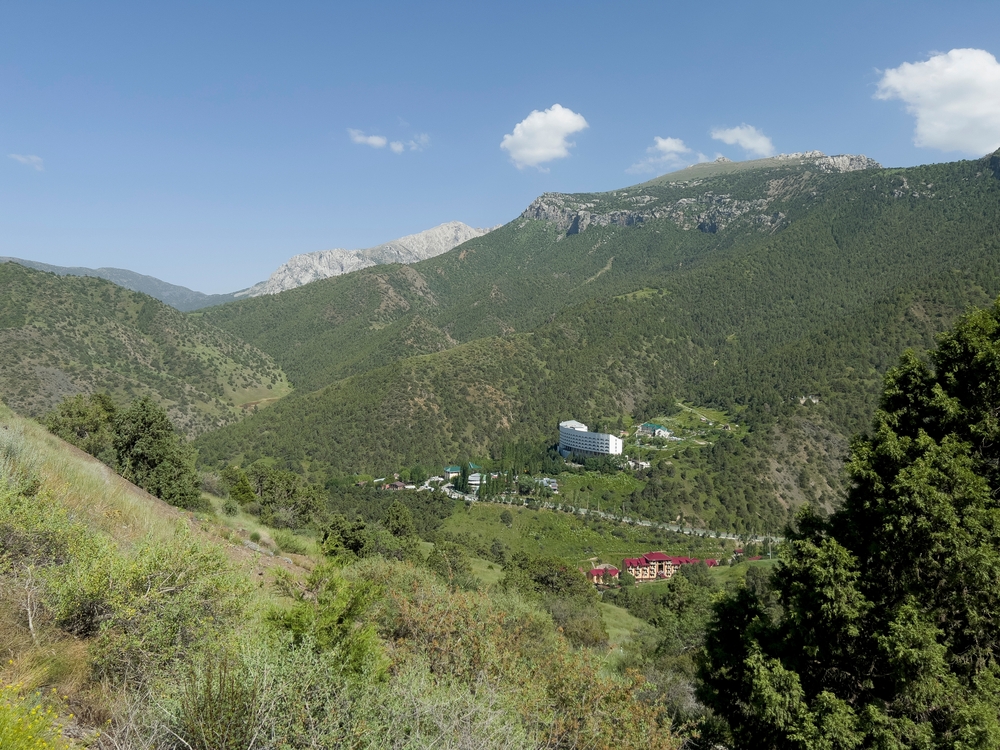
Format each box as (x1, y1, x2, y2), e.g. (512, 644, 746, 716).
(206, 152, 876, 388)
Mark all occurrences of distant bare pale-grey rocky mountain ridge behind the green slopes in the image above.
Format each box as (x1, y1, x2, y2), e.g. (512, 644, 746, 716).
(236, 221, 490, 297)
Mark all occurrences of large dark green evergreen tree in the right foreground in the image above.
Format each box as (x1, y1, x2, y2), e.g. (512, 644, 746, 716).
(699, 301, 1000, 748)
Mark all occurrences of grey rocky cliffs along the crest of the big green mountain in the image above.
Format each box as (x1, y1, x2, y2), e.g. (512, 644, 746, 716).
(521, 151, 881, 236)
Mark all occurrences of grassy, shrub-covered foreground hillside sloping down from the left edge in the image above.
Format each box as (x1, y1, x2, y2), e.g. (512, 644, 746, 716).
(0, 402, 688, 750)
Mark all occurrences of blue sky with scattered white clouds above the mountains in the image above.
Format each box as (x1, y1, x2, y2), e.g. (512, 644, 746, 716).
(0, 0, 1000, 293)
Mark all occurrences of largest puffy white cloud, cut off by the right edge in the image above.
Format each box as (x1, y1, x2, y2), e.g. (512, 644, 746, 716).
(875, 49, 1000, 156)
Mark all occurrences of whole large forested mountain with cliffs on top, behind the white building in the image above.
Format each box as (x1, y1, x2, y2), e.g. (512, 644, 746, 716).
(193, 150, 1000, 522)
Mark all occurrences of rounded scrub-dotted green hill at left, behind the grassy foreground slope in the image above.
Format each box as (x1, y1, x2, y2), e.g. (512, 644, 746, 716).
(0, 263, 289, 435)
